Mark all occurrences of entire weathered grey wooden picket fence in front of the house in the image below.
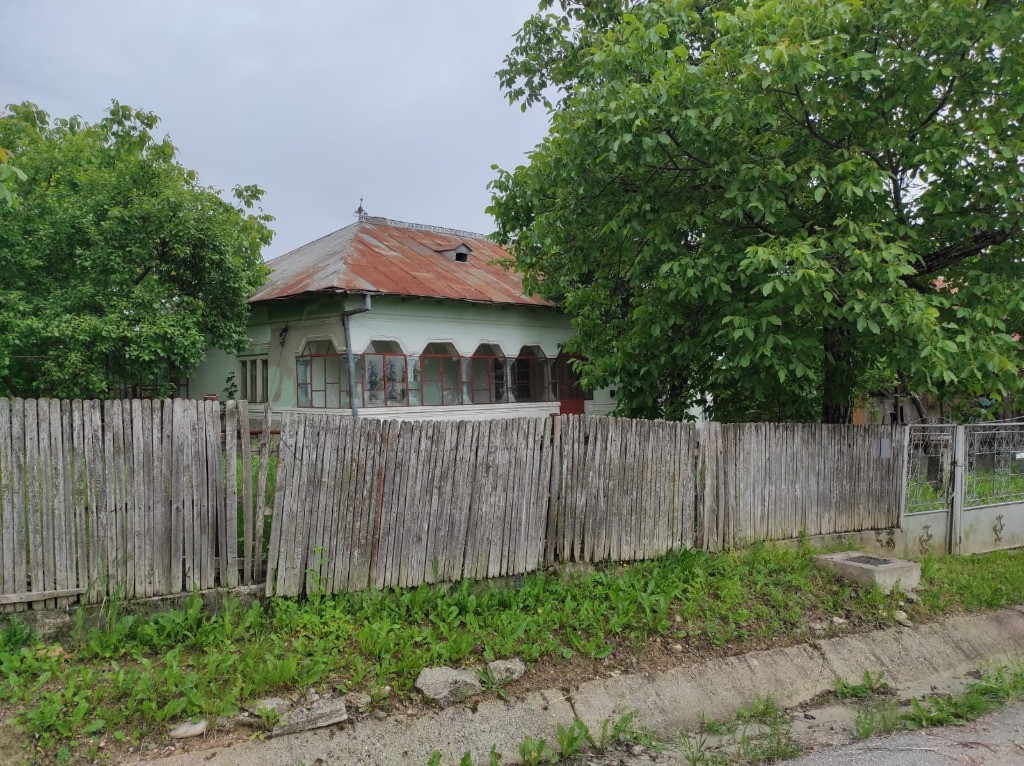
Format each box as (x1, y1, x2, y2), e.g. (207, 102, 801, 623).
(0, 399, 906, 611)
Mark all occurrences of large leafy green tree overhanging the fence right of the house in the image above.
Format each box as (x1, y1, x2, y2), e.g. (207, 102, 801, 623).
(490, 0, 1024, 422)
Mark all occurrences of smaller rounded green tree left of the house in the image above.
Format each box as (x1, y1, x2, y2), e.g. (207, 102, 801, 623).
(0, 101, 272, 397)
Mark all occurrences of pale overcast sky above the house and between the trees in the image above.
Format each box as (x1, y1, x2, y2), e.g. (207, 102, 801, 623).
(0, 0, 547, 257)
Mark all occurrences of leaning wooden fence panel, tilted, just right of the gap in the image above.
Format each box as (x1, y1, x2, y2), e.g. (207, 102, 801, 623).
(267, 414, 552, 595)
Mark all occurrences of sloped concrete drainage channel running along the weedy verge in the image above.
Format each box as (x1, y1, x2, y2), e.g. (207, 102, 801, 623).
(130, 607, 1024, 766)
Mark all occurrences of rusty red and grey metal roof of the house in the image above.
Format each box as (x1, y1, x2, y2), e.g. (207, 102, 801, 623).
(250, 218, 553, 306)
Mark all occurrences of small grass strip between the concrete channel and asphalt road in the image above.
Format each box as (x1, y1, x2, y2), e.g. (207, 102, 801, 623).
(853, 663, 1024, 739)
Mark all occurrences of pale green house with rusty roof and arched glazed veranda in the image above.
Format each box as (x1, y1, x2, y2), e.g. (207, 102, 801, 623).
(188, 215, 613, 420)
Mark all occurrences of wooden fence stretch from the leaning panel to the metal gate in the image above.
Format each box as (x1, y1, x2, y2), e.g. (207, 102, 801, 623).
(267, 414, 905, 596)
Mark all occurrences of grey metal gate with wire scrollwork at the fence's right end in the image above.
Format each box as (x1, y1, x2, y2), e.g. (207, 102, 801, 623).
(900, 420, 1024, 553)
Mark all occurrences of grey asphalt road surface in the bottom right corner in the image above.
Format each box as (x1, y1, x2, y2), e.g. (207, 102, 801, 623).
(787, 705, 1024, 766)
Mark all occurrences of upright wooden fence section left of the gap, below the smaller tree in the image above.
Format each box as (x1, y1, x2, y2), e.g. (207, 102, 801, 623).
(0, 399, 269, 611)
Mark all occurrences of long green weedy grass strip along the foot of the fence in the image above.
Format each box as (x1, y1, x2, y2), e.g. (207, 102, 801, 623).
(0, 545, 1024, 761)
